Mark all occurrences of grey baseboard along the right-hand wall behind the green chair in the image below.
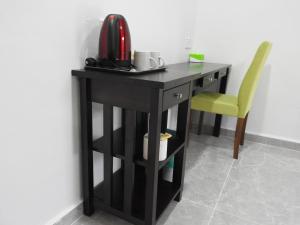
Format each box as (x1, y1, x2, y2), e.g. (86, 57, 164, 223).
(191, 124, 300, 151)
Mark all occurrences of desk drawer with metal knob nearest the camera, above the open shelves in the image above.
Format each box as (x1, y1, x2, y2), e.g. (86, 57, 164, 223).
(163, 84, 190, 110)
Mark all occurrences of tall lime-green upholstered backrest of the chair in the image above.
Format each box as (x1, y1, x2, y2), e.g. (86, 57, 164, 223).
(238, 41, 272, 118)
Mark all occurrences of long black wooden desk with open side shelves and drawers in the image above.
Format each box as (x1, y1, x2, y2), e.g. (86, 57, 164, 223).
(72, 63, 230, 225)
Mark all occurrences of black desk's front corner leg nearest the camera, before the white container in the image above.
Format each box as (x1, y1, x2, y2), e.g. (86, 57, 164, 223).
(145, 89, 163, 225)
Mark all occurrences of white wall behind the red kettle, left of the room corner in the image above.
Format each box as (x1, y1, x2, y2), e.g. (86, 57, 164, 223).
(0, 0, 195, 225)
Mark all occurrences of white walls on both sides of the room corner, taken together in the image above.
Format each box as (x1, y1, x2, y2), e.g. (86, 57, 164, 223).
(0, 0, 300, 225)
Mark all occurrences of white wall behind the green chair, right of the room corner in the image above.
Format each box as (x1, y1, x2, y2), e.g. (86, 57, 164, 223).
(193, 0, 300, 142)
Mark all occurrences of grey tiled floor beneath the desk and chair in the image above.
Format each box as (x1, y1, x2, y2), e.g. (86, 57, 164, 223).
(64, 135, 300, 225)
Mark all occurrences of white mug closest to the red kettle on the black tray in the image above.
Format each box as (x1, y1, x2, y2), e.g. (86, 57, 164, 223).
(133, 51, 158, 71)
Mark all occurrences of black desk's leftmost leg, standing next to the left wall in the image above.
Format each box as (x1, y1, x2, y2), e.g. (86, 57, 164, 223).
(80, 79, 94, 216)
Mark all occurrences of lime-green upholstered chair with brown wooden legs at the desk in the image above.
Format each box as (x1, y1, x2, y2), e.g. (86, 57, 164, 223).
(191, 42, 272, 159)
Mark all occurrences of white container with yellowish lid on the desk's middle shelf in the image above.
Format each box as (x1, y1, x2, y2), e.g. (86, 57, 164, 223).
(143, 133, 172, 161)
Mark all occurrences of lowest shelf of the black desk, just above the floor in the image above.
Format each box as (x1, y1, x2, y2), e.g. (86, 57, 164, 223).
(95, 168, 180, 224)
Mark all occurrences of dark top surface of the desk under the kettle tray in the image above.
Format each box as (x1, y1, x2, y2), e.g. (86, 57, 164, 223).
(72, 62, 231, 89)
